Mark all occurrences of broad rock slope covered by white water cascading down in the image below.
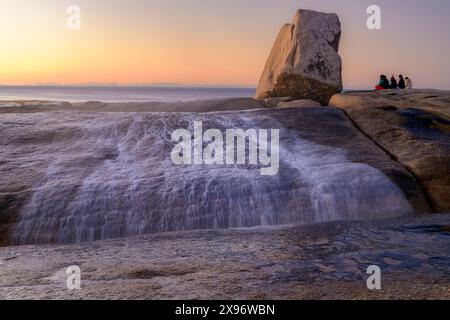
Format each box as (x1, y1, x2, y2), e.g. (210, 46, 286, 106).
(0, 107, 428, 244)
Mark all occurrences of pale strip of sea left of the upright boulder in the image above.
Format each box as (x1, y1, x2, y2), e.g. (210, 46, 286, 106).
(0, 86, 256, 102)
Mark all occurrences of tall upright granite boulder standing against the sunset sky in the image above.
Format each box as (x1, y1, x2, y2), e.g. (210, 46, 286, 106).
(255, 10, 342, 105)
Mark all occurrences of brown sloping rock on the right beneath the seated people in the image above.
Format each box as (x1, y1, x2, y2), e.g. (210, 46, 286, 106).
(330, 89, 450, 212)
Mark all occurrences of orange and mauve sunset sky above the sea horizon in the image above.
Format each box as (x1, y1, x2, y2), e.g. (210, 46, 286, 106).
(0, 0, 450, 89)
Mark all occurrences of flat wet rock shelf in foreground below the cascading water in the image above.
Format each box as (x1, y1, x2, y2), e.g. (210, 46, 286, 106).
(0, 215, 450, 299)
